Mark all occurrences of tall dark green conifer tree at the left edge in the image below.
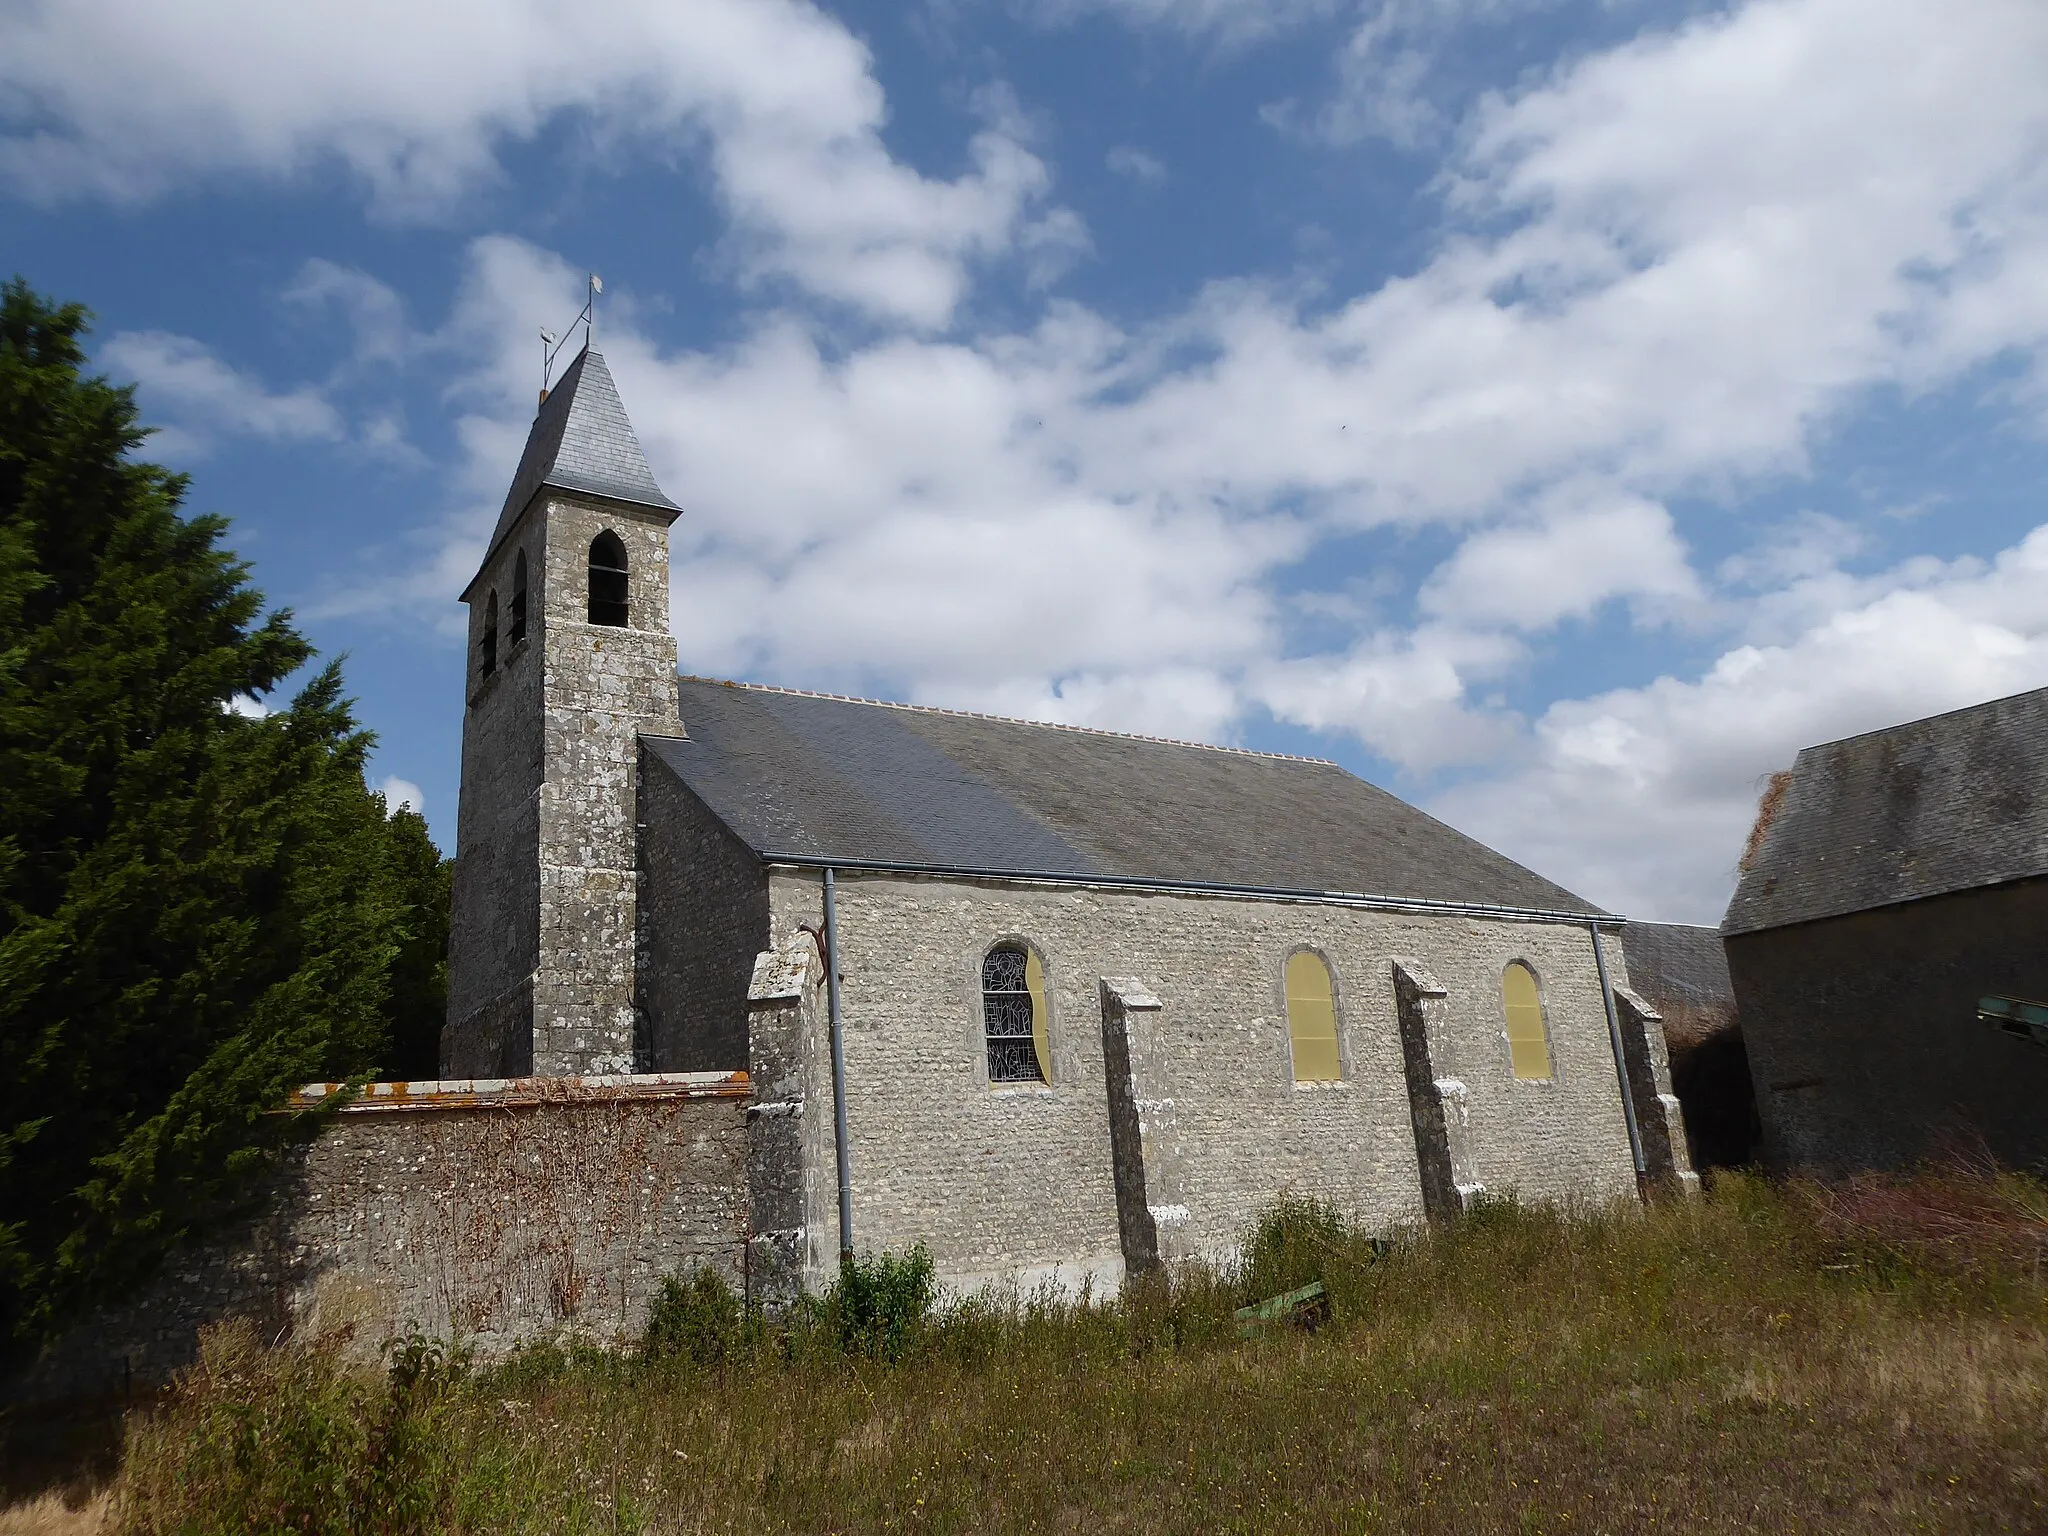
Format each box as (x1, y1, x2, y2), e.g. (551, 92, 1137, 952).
(0, 281, 446, 1352)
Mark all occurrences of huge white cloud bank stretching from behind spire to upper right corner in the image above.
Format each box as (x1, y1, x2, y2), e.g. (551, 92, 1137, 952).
(292, 0, 2048, 920)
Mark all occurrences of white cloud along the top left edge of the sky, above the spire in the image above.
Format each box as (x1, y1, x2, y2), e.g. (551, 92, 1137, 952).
(0, 0, 1081, 328)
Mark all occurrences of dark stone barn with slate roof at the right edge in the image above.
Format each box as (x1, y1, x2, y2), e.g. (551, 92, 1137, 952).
(1722, 690, 2048, 1174)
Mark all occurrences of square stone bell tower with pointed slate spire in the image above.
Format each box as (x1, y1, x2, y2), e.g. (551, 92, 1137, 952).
(440, 348, 682, 1077)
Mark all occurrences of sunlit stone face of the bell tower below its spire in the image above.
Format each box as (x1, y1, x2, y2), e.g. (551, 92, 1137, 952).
(532, 496, 682, 1077)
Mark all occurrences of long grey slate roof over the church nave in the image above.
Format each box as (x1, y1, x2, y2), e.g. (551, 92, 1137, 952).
(641, 678, 1599, 915)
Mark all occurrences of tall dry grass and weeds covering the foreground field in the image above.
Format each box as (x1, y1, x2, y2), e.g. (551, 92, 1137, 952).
(103, 1176, 2048, 1532)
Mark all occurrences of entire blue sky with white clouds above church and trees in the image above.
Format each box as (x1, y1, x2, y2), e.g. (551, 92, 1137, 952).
(0, 0, 2048, 922)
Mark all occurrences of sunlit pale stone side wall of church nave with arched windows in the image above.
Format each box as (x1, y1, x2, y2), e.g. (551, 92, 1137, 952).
(770, 870, 1636, 1286)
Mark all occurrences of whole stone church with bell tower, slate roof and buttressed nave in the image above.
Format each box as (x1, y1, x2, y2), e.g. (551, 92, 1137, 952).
(442, 350, 1692, 1288)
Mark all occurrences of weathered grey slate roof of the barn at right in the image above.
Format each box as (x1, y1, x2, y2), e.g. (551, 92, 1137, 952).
(1720, 688, 2048, 934)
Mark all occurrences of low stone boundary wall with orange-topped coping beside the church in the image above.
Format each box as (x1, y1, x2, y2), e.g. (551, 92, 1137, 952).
(6, 1073, 752, 1399)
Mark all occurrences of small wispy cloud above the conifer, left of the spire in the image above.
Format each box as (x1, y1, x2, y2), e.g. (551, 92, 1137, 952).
(98, 332, 348, 455)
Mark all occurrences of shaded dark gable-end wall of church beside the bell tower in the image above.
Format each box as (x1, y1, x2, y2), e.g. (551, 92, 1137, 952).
(637, 748, 768, 1071)
